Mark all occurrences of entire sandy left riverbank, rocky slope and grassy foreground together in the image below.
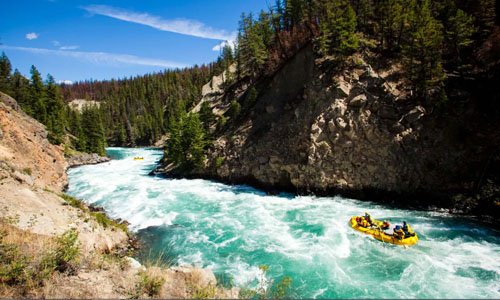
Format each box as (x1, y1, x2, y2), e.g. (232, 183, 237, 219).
(0, 93, 238, 299)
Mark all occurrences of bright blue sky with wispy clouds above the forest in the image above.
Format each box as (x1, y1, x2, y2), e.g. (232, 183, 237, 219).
(0, 0, 274, 82)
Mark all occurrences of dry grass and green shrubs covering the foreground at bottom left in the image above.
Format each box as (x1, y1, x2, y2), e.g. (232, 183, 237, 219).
(0, 219, 238, 299)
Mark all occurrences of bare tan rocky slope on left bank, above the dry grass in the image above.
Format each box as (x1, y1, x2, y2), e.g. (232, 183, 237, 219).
(0, 94, 128, 251)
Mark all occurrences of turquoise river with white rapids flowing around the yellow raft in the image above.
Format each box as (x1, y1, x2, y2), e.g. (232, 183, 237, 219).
(68, 148, 500, 298)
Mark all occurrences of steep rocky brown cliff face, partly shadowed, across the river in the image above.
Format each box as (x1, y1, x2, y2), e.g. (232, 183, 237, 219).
(174, 47, 500, 216)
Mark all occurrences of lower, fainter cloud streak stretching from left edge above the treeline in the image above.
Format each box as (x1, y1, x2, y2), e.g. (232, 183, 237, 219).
(0, 45, 186, 68)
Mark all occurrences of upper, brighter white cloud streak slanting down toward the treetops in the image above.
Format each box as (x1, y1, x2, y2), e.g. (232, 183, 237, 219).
(82, 5, 236, 41)
